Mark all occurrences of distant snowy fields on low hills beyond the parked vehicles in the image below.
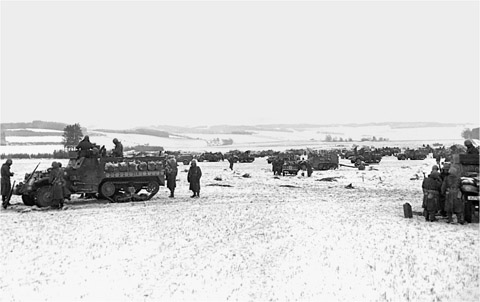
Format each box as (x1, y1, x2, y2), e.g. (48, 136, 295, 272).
(0, 126, 472, 154)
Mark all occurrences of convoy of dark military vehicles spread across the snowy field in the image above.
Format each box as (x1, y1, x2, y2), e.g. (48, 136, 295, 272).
(8, 140, 480, 222)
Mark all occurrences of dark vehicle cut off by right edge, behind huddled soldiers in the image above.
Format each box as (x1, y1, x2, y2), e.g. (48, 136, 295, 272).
(451, 154, 480, 223)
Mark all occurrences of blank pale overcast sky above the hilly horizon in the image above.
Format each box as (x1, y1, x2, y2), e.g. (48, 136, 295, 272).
(1, 1, 480, 128)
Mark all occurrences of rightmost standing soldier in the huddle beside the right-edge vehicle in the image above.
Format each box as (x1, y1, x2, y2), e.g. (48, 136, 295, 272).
(441, 167, 464, 224)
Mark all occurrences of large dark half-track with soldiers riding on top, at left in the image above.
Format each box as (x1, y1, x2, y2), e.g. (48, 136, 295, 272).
(14, 151, 165, 207)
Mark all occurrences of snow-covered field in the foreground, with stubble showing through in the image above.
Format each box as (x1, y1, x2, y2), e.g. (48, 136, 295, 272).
(0, 157, 480, 301)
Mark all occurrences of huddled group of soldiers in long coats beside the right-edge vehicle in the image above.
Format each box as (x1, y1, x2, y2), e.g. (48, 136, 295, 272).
(422, 140, 479, 224)
